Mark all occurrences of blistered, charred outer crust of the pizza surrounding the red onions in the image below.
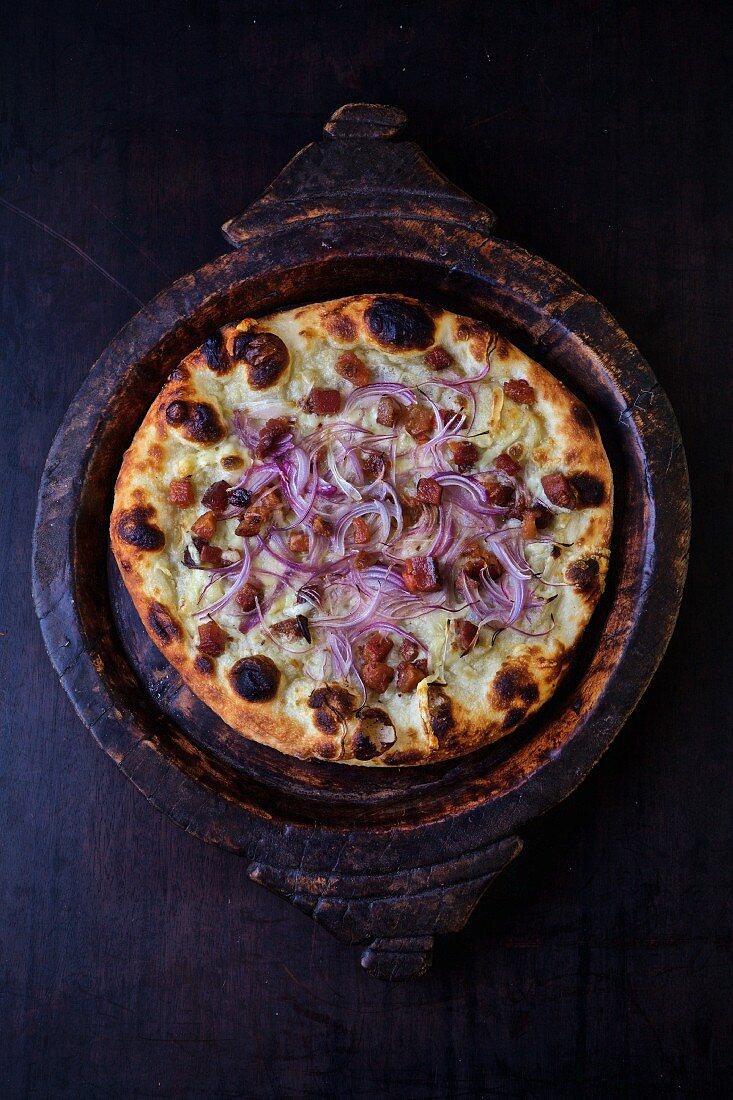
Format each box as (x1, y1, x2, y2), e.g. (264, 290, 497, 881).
(110, 295, 613, 766)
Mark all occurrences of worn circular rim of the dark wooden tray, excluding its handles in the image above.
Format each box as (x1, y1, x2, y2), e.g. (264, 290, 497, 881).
(33, 213, 689, 850)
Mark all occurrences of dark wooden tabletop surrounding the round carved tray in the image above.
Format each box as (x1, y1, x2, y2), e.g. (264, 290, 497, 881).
(0, 0, 733, 1100)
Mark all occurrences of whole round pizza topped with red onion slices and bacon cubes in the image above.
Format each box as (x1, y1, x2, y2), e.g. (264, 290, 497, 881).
(110, 294, 613, 767)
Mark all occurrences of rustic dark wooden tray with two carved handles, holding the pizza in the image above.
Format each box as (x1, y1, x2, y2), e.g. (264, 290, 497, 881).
(33, 103, 690, 979)
